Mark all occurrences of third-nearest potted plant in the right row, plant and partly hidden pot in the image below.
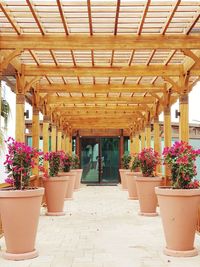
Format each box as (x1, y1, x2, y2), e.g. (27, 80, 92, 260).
(126, 154, 141, 199)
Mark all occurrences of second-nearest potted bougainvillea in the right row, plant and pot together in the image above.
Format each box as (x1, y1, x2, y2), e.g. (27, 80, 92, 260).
(135, 148, 162, 216)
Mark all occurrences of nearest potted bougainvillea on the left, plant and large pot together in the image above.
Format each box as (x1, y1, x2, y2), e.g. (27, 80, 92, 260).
(0, 137, 44, 260)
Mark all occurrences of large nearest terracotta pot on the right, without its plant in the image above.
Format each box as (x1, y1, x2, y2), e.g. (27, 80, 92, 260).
(155, 187, 200, 257)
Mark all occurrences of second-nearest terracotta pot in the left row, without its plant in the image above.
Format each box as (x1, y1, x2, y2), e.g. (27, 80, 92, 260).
(44, 176, 69, 216)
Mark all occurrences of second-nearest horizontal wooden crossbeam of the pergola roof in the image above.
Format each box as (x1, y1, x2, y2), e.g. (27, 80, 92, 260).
(24, 65, 182, 77)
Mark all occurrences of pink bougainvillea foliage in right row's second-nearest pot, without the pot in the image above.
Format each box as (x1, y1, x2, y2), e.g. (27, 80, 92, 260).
(138, 148, 160, 177)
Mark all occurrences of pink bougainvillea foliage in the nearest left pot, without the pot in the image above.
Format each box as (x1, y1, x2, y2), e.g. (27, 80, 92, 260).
(4, 137, 40, 190)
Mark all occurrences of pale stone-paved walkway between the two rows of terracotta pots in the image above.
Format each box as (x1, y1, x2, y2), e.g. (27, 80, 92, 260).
(0, 186, 200, 267)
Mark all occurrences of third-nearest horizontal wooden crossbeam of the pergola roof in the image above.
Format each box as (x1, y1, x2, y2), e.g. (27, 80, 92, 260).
(39, 84, 164, 93)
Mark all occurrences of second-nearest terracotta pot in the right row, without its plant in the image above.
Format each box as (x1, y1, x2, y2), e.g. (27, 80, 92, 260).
(135, 176, 162, 216)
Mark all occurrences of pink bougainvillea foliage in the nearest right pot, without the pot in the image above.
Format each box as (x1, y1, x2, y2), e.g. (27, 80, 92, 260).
(163, 141, 200, 189)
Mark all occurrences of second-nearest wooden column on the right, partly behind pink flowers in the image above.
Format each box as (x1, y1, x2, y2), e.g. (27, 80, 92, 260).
(164, 107, 172, 184)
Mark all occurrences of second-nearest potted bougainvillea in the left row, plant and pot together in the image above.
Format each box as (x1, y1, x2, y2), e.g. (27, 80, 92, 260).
(43, 151, 69, 216)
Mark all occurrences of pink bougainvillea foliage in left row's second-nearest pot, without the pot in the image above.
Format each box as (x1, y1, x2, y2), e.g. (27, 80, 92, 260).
(44, 151, 62, 177)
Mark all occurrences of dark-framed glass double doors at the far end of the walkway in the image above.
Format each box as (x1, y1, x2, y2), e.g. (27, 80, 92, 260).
(80, 137, 119, 183)
